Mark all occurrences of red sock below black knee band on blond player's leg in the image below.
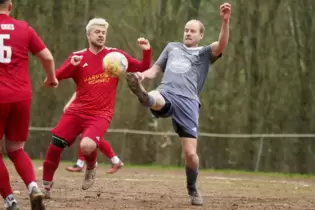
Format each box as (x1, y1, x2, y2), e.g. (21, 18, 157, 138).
(43, 144, 63, 182)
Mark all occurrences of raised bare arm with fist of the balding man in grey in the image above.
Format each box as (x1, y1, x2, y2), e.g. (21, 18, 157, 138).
(210, 3, 232, 57)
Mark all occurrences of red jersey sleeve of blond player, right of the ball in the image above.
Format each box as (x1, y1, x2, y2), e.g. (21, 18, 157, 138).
(120, 48, 152, 72)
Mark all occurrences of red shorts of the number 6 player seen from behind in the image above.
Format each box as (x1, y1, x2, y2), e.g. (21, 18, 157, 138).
(0, 100, 32, 142)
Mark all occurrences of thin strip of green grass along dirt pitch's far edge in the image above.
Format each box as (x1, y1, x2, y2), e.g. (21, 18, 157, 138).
(4, 158, 315, 179)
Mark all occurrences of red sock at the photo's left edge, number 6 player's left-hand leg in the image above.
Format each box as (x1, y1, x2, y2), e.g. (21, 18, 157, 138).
(0, 153, 13, 199)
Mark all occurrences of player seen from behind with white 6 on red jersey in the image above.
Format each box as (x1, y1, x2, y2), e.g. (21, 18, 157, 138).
(0, 0, 58, 210)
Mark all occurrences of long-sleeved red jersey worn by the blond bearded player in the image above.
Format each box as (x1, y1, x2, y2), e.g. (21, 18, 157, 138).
(56, 48, 152, 120)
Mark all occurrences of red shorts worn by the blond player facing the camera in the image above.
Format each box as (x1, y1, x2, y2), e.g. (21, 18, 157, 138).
(51, 113, 110, 146)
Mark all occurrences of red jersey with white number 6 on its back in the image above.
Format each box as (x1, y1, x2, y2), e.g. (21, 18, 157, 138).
(0, 14, 46, 103)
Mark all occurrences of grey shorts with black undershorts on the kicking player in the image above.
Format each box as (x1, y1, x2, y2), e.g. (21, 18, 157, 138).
(151, 92, 199, 138)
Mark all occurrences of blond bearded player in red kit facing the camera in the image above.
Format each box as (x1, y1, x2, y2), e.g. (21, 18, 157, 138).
(43, 18, 152, 198)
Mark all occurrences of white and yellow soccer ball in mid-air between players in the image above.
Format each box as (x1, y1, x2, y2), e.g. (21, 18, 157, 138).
(103, 52, 128, 77)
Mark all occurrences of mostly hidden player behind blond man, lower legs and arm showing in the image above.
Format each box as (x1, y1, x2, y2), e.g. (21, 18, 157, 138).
(63, 93, 124, 174)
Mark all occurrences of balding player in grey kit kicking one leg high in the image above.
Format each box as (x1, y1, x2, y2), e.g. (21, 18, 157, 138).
(127, 3, 231, 205)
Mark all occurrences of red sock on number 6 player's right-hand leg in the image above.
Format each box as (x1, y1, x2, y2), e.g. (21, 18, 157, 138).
(7, 149, 36, 186)
